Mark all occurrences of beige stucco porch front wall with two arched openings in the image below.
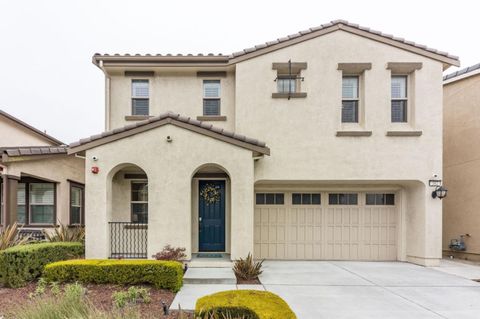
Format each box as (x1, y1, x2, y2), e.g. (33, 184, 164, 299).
(85, 125, 254, 258)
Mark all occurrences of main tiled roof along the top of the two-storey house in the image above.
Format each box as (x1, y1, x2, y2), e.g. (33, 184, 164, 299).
(92, 20, 460, 68)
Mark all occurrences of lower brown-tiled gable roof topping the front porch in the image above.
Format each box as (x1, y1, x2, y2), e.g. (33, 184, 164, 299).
(68, 112, 270, 155)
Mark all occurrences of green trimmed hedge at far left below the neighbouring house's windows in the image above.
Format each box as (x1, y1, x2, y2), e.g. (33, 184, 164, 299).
(0, 242, 84, 288)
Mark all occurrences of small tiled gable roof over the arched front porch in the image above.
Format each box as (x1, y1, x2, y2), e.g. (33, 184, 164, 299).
(69, 112, 270, 154)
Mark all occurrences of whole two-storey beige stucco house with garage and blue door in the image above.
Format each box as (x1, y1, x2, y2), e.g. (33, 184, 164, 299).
(68, 21, 459, 265)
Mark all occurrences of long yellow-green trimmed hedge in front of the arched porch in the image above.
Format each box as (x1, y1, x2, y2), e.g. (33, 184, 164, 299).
(43, 259, 183, 292)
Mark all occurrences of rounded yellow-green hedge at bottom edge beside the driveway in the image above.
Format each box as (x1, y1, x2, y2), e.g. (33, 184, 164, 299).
(195, 290, 297, 319)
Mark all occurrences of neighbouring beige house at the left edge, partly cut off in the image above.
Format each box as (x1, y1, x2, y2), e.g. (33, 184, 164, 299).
(0, 110, 85, 230)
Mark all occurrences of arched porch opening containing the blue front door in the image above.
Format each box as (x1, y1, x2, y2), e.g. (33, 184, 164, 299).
(192, 164, 230, 253)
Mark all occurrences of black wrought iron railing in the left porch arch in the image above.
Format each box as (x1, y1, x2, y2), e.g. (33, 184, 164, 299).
(108, 222, 148, 259)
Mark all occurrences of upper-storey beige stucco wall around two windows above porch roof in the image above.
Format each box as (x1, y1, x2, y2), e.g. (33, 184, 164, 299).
(107, 71, 235, 130)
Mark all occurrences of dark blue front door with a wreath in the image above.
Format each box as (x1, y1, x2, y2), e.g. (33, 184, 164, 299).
(198, 180, 225, 251)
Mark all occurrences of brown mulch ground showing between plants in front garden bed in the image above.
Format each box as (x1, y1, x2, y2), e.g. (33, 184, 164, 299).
(0, 283, 193, 319)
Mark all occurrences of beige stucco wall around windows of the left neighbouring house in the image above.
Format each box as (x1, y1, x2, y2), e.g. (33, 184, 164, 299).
(5, 155, 85, 224)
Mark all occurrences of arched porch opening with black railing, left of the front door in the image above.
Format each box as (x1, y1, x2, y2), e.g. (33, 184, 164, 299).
(107, 164, 148, 258)
